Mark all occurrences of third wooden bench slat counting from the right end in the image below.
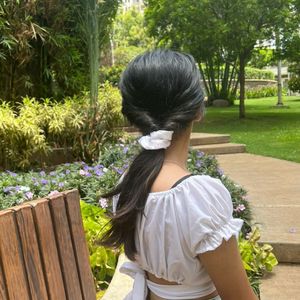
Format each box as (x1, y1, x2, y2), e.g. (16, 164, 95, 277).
(30, 199, 67, 300)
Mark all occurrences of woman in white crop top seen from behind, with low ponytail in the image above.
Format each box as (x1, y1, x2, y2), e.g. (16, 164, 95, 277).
(102, 50, 257, 300)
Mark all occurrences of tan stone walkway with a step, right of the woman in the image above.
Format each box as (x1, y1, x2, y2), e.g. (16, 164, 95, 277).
(217, 153, 300, 300)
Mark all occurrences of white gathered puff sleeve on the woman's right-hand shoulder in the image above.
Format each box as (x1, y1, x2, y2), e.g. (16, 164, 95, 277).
(185, 176, 243, 256)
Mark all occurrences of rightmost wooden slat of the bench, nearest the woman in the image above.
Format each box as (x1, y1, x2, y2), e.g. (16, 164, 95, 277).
(64, 190, 96, 300)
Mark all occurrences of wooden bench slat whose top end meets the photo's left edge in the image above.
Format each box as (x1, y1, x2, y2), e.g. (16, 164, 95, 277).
(0, 210, 30, 300)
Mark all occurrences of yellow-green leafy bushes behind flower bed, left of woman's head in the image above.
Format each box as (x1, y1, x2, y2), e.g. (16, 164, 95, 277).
(0, 82, 124, 169)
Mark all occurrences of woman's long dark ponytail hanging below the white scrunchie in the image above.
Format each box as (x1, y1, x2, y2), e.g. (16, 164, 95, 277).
(101, 149, 165, 260)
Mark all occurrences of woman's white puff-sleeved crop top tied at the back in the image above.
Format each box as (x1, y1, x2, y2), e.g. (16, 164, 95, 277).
(120, 175, 243, 300)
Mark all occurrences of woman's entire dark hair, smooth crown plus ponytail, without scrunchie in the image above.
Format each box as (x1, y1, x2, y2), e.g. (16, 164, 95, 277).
(100, 49, 203, 260)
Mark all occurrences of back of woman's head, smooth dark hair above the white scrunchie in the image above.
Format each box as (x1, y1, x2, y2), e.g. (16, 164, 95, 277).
(120, 50, 203, 134)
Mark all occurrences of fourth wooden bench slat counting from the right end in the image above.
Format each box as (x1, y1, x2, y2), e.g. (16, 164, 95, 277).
(14, 205, 48, 300)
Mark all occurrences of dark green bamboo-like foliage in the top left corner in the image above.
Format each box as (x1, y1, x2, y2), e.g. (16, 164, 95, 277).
(0, 0, 119, 102)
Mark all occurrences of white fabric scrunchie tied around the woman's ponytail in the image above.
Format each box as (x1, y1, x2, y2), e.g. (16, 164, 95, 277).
(138, 130, 174, 150)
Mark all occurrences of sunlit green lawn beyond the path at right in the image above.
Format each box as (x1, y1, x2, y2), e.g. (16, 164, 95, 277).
(194, 97, 300, 163)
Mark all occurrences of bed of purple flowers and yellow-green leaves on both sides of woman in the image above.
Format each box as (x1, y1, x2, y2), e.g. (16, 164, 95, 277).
(0, 140, 277, 296)
